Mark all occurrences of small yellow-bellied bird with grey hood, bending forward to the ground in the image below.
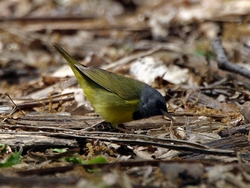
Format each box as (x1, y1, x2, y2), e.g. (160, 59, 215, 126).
(54, 44, 172, 126)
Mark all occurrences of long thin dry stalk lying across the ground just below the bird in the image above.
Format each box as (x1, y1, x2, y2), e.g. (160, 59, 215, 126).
(0, 132, 239, 156)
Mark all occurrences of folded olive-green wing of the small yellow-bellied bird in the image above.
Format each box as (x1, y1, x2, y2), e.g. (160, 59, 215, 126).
(75, 64, 145, 100)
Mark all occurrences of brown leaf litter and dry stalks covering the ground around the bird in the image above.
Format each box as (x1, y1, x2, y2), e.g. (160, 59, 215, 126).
(0, 0, 250, 187)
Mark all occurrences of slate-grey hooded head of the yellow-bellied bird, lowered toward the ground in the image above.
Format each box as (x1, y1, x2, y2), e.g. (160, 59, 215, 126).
(133, 84, 167, 120)
